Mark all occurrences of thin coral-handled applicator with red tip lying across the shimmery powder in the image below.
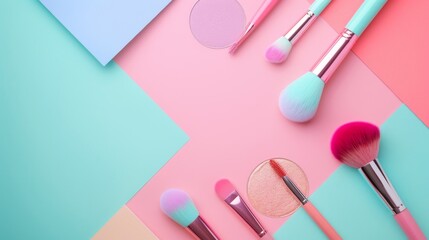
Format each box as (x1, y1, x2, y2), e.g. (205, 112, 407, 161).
(270, 160, 341, 240)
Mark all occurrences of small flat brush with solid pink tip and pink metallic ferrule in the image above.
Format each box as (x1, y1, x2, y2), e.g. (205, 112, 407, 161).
(215, 179, 274, 240)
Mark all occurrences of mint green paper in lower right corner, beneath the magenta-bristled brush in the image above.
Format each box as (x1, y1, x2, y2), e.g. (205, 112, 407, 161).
(275, 105, 429, 240)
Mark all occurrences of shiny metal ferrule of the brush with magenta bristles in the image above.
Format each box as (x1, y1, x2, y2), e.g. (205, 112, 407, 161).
(360, 159, 406, 214)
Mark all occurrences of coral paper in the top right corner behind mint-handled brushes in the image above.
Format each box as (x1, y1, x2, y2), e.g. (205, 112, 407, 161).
(322, 0, 429, 126)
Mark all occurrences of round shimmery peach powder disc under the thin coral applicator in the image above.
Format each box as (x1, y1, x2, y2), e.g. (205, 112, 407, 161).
(247, 158, 309, 217)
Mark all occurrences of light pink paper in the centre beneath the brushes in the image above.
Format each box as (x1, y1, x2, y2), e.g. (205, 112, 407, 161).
(105, 0, 400, 239)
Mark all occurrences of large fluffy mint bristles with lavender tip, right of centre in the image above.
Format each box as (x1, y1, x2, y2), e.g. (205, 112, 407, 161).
(279, 72, 325, 122)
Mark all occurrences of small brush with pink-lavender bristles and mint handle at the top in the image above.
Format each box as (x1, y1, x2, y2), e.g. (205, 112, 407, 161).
(265, 0, 331, 63)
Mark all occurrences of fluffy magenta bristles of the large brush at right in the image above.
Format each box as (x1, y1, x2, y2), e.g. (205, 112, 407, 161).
(331, 122, 380, 168)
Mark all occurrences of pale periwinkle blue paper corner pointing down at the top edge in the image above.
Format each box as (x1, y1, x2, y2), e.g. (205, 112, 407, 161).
(40, 0, 171, 65)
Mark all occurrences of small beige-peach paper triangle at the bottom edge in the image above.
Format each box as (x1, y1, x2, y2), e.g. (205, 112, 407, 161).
(92, 207, 158, 240)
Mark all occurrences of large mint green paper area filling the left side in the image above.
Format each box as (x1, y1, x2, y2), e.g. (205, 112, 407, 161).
(0, 0, 188, 240)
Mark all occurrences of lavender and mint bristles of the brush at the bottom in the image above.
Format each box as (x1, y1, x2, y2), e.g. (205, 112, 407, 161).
(160, 189, 200, 227)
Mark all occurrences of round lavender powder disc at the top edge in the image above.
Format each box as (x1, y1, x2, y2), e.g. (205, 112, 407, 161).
(189, 0, 246, 48)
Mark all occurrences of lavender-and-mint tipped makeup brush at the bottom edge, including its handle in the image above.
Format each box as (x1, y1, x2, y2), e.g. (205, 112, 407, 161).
(160, 189, 218, 240)
